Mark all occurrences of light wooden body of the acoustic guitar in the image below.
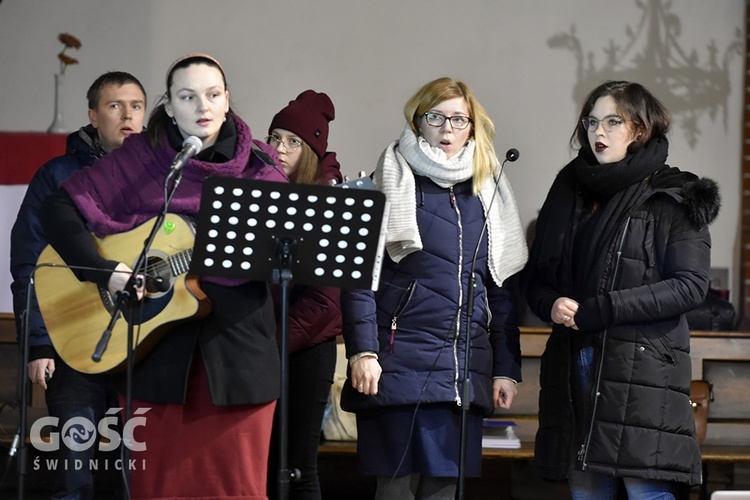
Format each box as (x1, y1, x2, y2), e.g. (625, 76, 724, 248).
(34, 214, 210, 373)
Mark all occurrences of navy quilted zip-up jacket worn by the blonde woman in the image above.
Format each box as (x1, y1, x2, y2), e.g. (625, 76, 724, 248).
(341, 177, 521, 414)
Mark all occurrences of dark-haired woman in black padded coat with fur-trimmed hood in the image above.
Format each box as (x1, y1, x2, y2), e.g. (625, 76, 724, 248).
(525, 81, 719, 499)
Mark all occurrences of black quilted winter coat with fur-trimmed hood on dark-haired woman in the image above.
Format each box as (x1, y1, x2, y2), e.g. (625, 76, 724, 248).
(527, 167, 719, 485)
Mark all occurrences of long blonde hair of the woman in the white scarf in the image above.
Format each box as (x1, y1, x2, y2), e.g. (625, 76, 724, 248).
(404, 77, 498, 194)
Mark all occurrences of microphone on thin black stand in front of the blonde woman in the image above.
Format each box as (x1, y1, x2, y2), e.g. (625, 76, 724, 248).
(456, 149, 518, 500)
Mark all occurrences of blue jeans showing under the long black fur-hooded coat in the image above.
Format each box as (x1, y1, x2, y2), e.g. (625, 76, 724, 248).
(568, 347, 677, 500)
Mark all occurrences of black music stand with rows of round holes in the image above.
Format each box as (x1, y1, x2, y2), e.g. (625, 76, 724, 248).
(190, 177, 387, 500)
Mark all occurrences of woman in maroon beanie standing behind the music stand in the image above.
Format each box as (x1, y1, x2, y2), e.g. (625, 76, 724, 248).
(266, 90, 342, 500)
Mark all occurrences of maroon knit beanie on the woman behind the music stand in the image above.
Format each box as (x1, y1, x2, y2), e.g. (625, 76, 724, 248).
(268, 90, 335, 158)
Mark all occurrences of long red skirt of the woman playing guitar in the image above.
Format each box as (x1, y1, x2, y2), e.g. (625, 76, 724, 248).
(120, 354, 276, 500)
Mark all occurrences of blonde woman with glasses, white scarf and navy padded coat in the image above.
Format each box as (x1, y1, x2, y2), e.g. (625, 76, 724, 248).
(341, 78, 527, 499)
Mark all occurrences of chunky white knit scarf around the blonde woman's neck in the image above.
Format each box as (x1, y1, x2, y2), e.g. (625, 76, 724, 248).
(374, 124, 528, 285)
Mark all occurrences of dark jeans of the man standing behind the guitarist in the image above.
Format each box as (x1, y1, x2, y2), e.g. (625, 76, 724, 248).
(44, 358, 122, 500)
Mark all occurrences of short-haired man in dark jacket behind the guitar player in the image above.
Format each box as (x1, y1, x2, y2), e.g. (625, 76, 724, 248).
(10, 71, 146, 499)
